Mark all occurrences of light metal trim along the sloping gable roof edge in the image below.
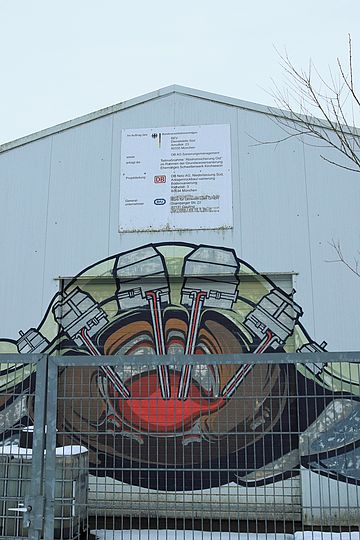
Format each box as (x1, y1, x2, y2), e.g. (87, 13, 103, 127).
(0, 84, 360, 153)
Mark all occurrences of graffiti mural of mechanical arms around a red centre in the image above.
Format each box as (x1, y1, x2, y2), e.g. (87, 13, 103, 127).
(0, 243, 360, 491)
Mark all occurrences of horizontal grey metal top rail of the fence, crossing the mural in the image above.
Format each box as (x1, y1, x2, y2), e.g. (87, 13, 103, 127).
(0, 351, 360, 367)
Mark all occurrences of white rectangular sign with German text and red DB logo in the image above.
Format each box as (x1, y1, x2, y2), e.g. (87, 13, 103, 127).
(119, 125, 233, 232)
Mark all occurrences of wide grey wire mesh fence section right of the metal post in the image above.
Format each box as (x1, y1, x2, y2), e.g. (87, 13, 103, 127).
(50, 353, 360, 538)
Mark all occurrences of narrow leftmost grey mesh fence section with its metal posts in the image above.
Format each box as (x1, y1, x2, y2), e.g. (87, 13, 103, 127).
(0, 355, 46, 539)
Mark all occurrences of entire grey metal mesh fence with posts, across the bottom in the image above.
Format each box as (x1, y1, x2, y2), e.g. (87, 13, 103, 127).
(0, 352, 360, 540)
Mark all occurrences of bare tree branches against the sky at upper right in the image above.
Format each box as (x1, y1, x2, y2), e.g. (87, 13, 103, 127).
(264, 35, 360, 173)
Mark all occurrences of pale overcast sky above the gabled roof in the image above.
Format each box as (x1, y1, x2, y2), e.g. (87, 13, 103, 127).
(0, 0, 360, 143)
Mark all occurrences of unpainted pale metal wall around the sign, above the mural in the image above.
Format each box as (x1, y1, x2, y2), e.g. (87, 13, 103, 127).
(0, 88, 360, 350)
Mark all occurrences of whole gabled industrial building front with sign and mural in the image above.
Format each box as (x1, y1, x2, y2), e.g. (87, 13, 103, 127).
(0, 86, 360, 523)
